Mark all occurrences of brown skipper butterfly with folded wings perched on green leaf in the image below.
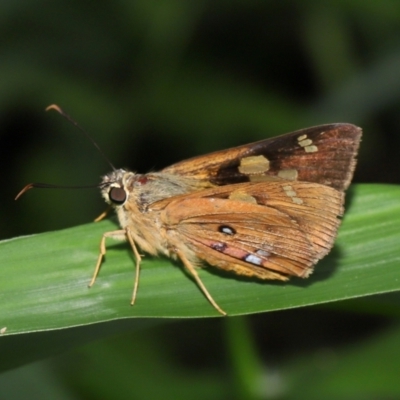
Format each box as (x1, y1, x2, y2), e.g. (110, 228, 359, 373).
(18, 106, 361, 315)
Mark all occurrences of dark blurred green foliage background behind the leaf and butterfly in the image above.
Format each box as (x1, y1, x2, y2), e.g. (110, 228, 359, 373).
(0, 0, 400, 399)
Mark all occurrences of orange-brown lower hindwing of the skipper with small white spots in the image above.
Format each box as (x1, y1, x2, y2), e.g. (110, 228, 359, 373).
(159, 182, 344, 280)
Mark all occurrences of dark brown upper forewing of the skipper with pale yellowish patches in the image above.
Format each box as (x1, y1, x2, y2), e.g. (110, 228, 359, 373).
(162, 124, 361, 190)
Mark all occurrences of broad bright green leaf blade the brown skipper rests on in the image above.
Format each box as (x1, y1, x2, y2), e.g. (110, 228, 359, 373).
(0, 185, 400, 334)
